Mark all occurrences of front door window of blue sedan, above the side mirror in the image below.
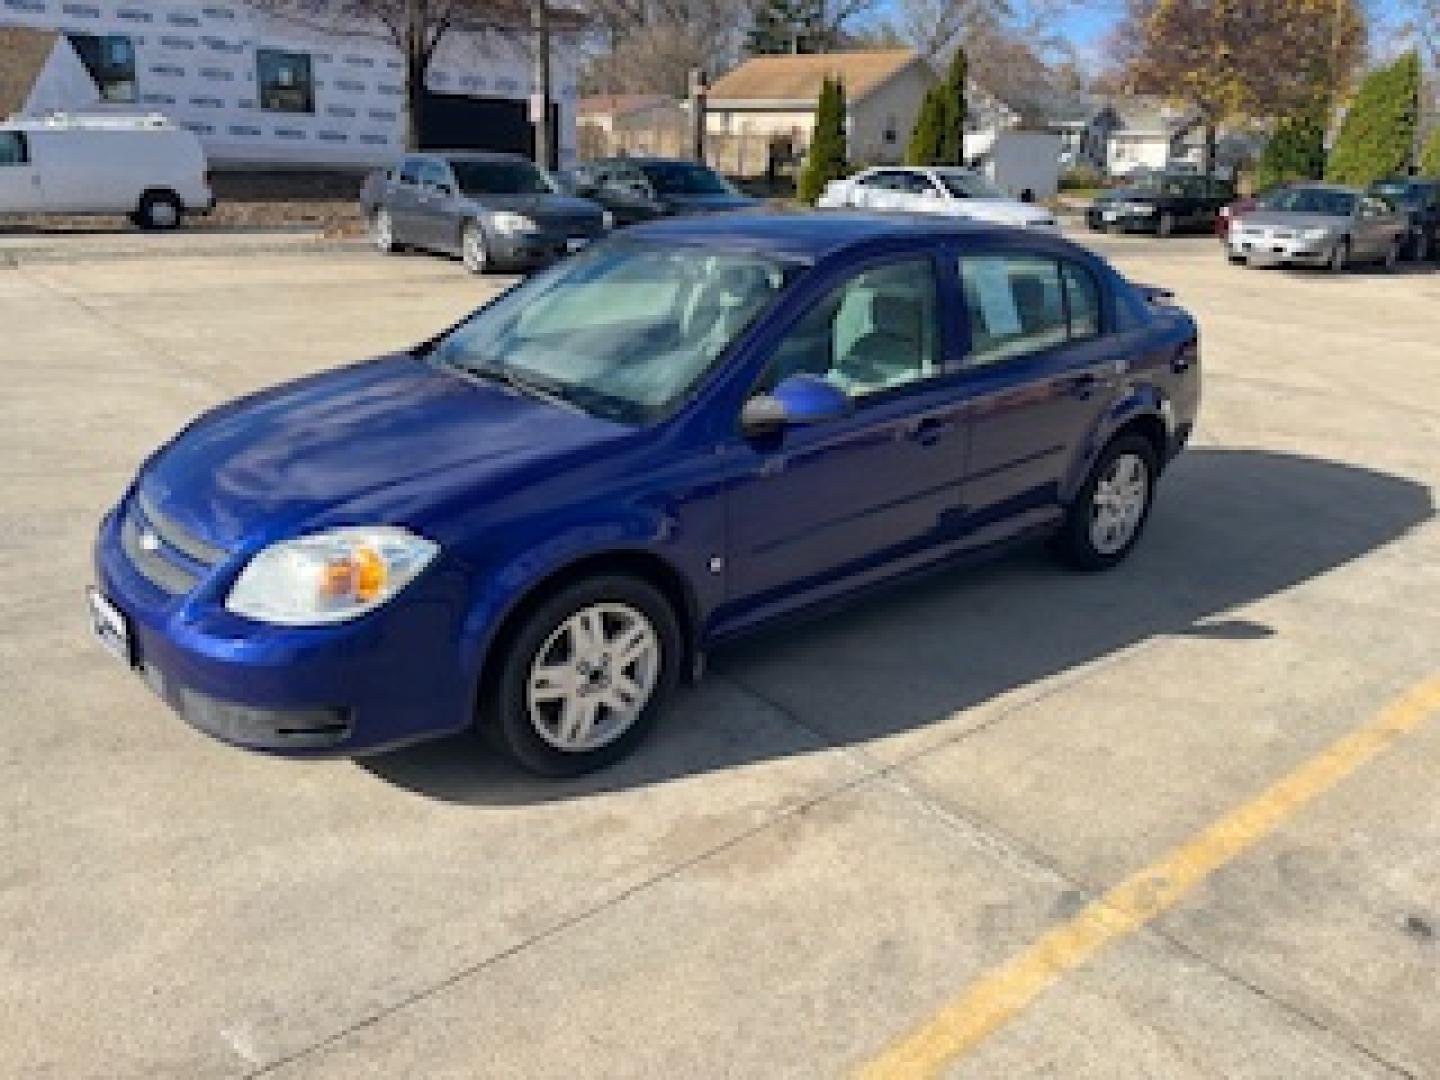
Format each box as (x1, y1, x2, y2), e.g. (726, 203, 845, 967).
(760, 258, 940, 397)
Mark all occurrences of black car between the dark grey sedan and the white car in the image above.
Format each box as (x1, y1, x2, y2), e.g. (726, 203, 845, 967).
(572, 157, 760, 226)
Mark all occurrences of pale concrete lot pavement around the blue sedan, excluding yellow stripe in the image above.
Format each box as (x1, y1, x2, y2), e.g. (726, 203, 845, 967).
(0, 238, 1440, 1077)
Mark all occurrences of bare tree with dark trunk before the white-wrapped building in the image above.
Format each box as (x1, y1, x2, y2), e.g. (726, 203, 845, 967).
(251, 0, 546, 150)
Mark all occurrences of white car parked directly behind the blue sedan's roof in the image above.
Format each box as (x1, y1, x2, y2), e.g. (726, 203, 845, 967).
(815, 166, 1060, 232)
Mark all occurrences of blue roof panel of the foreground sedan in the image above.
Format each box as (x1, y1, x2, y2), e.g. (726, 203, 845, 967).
(624, 210, 1022, 262)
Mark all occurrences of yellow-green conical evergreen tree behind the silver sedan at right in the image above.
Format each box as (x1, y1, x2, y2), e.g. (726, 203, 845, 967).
(1325, 50, 1420, 187)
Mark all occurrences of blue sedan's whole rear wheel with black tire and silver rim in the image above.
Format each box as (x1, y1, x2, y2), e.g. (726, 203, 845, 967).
(1051, 435, 1159, 570)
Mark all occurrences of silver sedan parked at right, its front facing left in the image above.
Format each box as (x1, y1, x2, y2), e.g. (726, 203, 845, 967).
(1225, 184, 1408, 274)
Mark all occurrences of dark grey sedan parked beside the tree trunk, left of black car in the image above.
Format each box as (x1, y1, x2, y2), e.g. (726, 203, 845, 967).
(360, 151, 612, 274)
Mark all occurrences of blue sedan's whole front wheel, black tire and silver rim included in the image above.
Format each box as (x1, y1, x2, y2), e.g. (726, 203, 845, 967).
(480, 575, 684, 778)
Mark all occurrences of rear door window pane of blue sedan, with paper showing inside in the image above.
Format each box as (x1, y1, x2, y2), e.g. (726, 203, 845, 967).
(960, 255, 1070, 367)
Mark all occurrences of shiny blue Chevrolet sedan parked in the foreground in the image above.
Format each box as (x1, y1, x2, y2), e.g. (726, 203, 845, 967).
(89, 215, 1200, 776)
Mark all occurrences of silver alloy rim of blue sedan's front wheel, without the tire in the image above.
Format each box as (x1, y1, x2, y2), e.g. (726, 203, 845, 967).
(526, 603, 661, 753)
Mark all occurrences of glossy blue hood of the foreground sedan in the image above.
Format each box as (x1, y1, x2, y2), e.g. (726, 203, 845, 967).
(140, 354, 634, 547)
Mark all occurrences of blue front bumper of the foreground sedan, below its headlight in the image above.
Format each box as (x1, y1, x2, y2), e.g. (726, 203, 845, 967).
(95, 507, 478, 757)
